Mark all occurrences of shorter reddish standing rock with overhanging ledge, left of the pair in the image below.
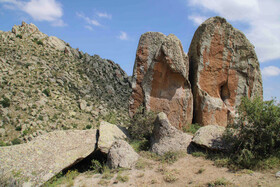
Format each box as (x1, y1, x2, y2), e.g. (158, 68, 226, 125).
(129, 32, 193, 128)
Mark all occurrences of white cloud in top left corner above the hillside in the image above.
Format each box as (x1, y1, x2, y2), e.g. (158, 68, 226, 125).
(0, 0, 66, 26)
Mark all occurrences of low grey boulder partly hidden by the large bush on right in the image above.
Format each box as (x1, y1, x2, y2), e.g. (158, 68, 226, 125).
(192, 125, 226, 150)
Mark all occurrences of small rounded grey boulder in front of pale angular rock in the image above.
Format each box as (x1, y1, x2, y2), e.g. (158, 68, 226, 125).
(107, 140, 139, 169)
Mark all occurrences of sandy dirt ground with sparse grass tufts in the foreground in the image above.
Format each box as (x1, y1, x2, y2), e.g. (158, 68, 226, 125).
(68, 155, 280, 187)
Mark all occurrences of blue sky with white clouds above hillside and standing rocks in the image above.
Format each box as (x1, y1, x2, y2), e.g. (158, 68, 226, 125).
(0, 0, 280, 101)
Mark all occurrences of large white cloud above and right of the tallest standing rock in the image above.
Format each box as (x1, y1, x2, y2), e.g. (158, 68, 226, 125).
(188, 0, 280, 62)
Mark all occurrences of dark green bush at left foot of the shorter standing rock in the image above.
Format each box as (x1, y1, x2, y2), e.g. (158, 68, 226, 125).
(128, 107, 156, 140)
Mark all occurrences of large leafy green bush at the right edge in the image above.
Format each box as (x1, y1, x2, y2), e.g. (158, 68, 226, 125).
(227, 98, 280, 168)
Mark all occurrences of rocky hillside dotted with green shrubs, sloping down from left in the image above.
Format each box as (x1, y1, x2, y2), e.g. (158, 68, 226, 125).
(0, 22, 131, 145)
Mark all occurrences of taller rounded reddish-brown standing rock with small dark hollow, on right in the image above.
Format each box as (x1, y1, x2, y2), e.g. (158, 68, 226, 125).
(189, 17, 263, 126)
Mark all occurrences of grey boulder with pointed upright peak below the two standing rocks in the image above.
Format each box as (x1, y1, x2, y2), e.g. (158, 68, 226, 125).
(151, 112, 193, 155)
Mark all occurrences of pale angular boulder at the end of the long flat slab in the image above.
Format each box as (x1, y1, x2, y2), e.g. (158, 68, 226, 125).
(98, 121, 127, 154)
